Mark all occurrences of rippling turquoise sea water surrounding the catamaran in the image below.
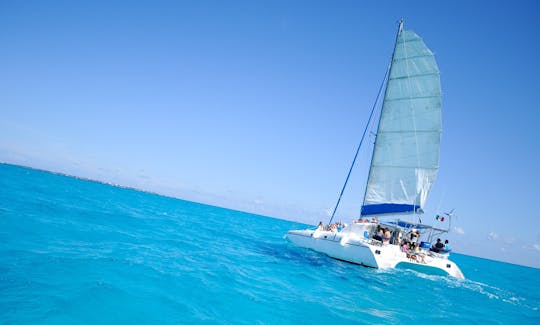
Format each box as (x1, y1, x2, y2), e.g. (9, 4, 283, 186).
(0, 164, 540, 324)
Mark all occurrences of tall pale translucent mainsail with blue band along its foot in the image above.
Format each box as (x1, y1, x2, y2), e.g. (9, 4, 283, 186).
(361, 23, 441, 215)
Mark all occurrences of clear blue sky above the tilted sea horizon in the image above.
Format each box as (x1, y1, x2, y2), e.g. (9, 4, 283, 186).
(0, 1, 540, 267)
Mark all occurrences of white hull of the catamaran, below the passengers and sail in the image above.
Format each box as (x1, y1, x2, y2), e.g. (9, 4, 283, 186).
(287, 225, 464, 279)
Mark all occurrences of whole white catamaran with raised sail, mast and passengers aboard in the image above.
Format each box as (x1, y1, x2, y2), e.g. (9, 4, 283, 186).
(286, 20, 464, 279)
